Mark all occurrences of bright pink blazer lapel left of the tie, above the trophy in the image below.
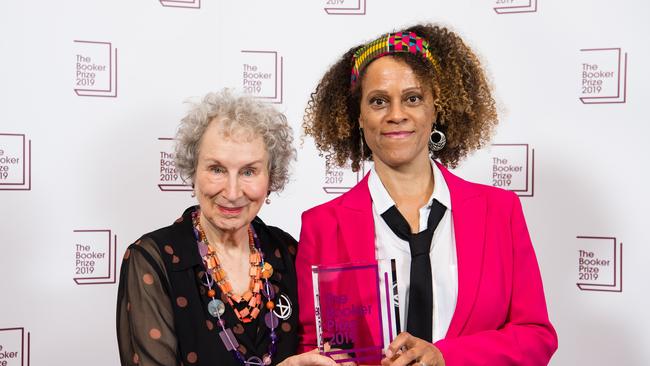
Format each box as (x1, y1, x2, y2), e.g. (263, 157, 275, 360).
(336, 174, 375, 262)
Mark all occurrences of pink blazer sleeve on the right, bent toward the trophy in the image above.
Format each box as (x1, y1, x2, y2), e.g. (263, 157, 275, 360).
(435, 194, 557, 366)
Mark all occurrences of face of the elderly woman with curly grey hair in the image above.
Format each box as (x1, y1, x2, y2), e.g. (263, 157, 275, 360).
(194, 121, 269, 232)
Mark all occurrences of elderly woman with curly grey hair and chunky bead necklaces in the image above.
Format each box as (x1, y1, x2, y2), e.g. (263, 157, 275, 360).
(117, 91, 335, 366)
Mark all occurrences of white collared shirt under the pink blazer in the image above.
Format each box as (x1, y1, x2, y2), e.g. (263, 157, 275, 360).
(368, 161, 458, 342)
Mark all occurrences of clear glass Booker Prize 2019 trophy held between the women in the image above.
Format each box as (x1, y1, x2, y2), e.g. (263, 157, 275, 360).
(312, 259, 400, 364)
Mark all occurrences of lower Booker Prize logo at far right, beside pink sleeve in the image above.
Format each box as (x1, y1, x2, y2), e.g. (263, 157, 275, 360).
(576, 236, 623, 292)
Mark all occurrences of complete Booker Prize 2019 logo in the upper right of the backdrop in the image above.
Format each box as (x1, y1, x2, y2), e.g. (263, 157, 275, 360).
(580, 48, 627, 104)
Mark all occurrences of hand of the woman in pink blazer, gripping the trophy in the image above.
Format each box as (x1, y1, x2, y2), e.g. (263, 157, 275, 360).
(381, 332, 445, 366)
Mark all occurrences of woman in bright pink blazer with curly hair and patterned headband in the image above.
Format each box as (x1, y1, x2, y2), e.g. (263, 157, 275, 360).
(296, 25, 557, 366)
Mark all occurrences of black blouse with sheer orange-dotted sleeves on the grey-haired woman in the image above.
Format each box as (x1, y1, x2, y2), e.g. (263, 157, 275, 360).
(117, 207, 298, 366)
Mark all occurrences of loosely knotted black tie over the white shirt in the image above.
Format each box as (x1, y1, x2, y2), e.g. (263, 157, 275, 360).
(381, 199, 447, 342)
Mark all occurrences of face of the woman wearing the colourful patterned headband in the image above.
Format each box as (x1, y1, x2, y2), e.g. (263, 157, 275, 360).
(359, 56, 435, 168)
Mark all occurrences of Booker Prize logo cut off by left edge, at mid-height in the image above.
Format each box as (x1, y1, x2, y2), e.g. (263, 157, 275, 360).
(0, 133, 32, 192)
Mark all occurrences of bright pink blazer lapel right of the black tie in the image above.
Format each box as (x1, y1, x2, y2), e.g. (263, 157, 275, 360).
(436, 162, 487, 337)
